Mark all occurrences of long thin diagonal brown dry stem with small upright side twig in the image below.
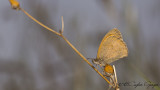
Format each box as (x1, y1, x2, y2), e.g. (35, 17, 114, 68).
(20, 8, 111, 85)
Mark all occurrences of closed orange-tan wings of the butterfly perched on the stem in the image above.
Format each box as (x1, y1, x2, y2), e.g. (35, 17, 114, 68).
(97, 29, 128, 64)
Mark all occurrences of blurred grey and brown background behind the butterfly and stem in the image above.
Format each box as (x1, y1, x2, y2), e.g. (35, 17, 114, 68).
(0, 0, 160, 90)
